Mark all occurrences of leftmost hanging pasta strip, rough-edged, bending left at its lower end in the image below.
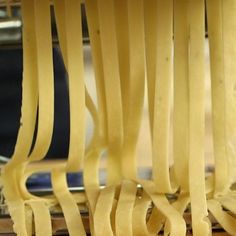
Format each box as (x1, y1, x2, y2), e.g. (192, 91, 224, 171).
(5, 0, 38, 177)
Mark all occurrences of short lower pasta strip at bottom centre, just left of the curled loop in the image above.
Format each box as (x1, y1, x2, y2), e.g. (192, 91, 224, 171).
(115, 180, 137, 236)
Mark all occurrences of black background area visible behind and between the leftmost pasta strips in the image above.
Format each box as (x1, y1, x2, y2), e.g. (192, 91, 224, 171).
(0, 47, 69, 158)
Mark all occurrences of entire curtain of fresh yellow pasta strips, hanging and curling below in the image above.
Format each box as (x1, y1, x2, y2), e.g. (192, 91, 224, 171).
(1, 0, 236, 236)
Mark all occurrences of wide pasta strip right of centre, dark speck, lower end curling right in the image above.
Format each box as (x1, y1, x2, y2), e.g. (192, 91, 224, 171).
(152, 0, 175, 193)
